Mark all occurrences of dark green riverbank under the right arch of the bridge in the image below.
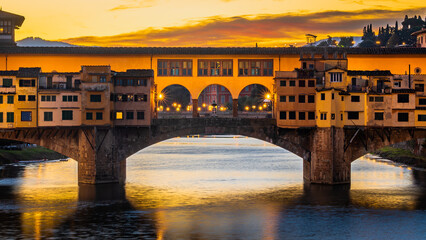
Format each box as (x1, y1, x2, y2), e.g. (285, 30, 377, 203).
(373, 147, 426, 170)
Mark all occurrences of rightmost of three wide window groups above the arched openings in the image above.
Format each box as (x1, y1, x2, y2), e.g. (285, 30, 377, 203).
(238, 60, 273, 76)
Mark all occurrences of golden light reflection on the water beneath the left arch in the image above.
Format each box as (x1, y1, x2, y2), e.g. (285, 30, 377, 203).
(17, 160, 78, 239)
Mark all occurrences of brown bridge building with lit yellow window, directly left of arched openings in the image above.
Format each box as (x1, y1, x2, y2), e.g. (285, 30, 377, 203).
(113, 69, 156, 126)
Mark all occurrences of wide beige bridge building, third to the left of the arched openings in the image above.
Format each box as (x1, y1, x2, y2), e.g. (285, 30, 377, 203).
(38, 72, 82, 127)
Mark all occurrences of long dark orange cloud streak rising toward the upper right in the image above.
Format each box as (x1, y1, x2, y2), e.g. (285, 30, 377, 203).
(63, 8, 426, 47)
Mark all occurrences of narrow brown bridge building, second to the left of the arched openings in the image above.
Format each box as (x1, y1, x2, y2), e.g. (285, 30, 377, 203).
(80, 66, 114, 126)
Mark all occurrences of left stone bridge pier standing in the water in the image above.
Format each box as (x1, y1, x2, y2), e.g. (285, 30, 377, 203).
(77, 127, 126, 185)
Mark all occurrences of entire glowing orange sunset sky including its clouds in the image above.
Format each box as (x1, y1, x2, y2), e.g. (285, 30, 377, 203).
(1, 0, 426, 46)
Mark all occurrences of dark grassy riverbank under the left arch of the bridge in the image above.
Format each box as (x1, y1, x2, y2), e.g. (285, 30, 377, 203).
(0, 147, 67, 165)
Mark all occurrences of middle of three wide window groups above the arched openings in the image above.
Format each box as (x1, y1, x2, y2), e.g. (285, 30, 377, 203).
(198, 60, 232, 76)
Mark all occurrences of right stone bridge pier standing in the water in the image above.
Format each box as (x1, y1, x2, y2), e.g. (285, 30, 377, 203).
(303, 127, 351, 184)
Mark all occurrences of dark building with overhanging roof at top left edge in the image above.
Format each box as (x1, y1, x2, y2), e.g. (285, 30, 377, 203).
(0, 10, 25, 47)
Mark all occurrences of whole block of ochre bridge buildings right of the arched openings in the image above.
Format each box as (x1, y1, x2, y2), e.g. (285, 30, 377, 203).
(275, 53, 426, 128)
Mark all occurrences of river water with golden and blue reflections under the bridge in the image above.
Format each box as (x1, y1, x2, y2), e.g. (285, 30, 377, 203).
(0, 136, 426, 240)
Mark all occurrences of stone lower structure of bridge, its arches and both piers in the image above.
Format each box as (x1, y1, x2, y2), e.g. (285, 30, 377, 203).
(0, 118, 426, 184)
